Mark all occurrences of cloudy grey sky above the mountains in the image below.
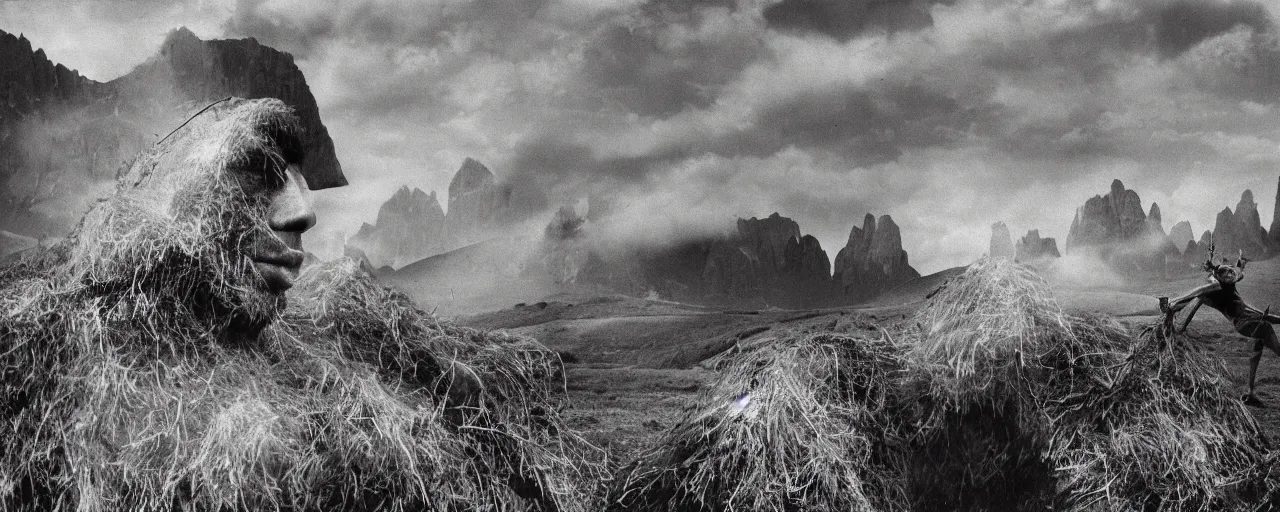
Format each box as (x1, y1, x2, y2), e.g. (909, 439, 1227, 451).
(0, 0, 1280, 273)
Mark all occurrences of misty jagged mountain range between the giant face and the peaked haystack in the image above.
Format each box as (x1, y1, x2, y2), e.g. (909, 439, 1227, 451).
(366, 167, 919, 308)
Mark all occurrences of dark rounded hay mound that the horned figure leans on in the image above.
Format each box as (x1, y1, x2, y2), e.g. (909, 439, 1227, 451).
(1038, 313, 1270, 511)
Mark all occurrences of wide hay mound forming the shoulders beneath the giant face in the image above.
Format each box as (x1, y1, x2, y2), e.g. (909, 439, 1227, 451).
(0, 253, 595, 511)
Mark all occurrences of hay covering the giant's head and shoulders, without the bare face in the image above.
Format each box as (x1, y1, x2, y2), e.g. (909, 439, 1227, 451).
(0, 100, 596, 511)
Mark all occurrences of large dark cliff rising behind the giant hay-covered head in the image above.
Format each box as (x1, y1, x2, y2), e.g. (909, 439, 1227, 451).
(0, 28, 347, 236)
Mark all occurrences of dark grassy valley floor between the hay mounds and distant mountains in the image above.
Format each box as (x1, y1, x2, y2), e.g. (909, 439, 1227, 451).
(458, 261, 1280, 473)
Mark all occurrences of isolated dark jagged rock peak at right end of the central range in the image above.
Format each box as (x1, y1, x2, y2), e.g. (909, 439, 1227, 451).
(833, 214, 920, 301)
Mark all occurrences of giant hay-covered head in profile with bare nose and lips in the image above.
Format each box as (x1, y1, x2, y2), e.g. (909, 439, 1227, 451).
(63, 100, 315, 332)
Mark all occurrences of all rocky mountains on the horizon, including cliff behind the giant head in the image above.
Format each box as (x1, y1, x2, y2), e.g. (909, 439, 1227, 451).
(12, 28, 1280, 312)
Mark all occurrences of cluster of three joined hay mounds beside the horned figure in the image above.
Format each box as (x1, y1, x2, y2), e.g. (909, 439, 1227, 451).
(609, 261, 1274, 511)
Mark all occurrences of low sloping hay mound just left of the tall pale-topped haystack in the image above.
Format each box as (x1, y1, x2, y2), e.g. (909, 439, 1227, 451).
(605, 334, 901, 511)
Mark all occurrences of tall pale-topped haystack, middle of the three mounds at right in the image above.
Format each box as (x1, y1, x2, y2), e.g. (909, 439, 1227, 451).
(899, 260, 1069, 509)
